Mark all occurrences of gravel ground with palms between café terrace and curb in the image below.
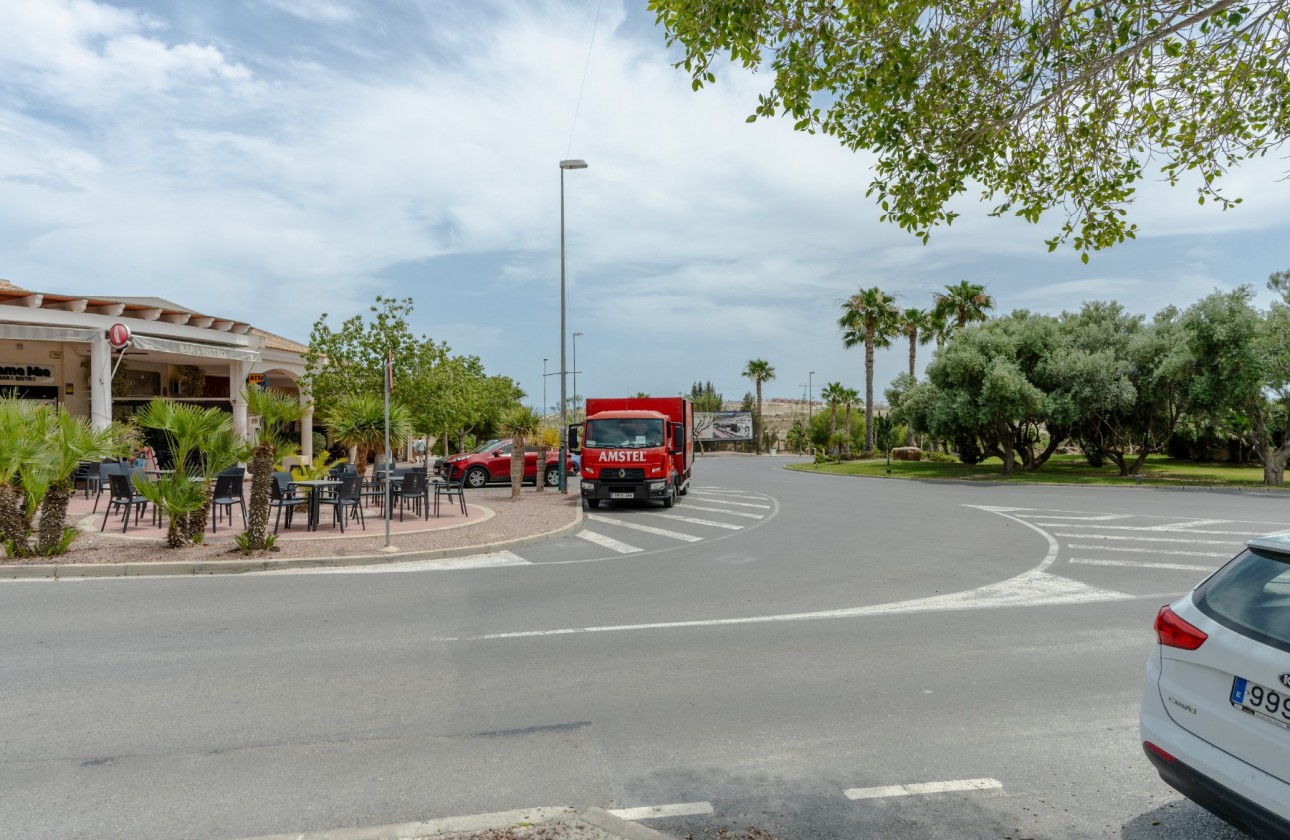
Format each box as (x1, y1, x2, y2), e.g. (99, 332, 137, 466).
(0, 488, 581, 565)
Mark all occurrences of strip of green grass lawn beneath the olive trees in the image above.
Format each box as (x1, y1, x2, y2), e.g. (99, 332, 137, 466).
(788, 455, 1284, 488)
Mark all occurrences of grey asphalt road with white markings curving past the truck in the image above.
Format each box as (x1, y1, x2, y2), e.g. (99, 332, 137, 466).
(0, 458, 1274, 840)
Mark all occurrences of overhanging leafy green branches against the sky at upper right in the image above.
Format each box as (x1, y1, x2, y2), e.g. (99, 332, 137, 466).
(649, 0, 1290, 261)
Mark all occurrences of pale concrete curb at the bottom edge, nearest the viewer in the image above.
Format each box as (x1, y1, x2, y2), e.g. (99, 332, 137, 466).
(228, 806, 672, 840)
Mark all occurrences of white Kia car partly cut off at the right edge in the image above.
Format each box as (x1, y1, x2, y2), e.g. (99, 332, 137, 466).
(1140, 534, 1290, 837)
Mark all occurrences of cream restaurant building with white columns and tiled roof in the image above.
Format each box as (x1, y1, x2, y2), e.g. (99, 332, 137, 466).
(0, 280, 313, 463)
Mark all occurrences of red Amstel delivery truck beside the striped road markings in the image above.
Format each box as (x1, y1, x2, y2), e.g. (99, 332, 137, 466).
(575, 396, 694, 508)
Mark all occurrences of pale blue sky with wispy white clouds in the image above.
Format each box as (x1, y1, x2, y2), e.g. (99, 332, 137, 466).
(0, 0, 1290, 408)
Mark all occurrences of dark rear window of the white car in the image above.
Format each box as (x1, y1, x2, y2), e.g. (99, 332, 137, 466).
(1196, 548, 1290, 652)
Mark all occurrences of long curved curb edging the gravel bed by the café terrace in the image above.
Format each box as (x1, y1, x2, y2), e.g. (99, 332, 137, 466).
(0, 505, 583, 578)
